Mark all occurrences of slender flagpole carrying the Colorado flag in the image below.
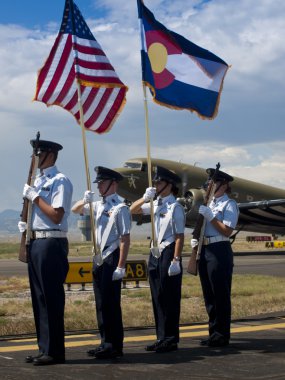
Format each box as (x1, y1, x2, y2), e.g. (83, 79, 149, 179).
(142, 82, 157, 247)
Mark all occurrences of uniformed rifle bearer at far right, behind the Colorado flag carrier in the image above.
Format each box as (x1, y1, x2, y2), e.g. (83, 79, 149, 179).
(191, 169, 239, 347)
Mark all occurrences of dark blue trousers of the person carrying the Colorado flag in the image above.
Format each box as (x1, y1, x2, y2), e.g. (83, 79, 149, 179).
(148, 243, 182, 343)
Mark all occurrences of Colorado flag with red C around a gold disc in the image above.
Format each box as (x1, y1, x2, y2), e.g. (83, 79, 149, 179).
(137, 0, 229, 119)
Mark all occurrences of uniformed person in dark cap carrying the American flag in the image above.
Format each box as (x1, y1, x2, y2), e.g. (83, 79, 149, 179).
(72, 166, 131, 359)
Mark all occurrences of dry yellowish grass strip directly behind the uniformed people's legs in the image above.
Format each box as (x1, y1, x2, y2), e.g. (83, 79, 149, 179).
(0, 274, 285, 336)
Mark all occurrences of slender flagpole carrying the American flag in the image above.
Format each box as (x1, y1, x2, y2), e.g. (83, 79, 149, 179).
(77, 81, 97, 255)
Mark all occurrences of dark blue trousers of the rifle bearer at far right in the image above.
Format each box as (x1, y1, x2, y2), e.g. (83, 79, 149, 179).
(199, 241, 233, 339)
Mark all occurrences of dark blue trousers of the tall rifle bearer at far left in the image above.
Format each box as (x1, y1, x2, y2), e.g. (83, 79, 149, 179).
(28, 238, 68, 359)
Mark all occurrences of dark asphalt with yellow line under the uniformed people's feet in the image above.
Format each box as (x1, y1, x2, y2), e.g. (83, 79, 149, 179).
(0, 313, 285, 380)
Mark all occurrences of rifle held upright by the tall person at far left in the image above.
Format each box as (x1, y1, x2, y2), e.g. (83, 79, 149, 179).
(18, 132, 40, 263)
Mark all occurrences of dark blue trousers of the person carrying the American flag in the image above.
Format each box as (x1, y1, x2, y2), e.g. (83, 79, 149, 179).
(93, 248, 124, 350)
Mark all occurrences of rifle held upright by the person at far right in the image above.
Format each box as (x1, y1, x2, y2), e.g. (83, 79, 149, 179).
(187, 162, 220, 276)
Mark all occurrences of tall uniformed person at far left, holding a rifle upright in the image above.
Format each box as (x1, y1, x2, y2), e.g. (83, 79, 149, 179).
(18, 140, 72, 365)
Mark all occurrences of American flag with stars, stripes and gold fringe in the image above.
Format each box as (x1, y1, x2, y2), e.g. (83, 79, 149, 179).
(34, 0, 128, 133)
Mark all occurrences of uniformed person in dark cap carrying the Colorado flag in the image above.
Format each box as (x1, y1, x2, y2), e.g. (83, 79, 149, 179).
(130, 166, 185, 352)
